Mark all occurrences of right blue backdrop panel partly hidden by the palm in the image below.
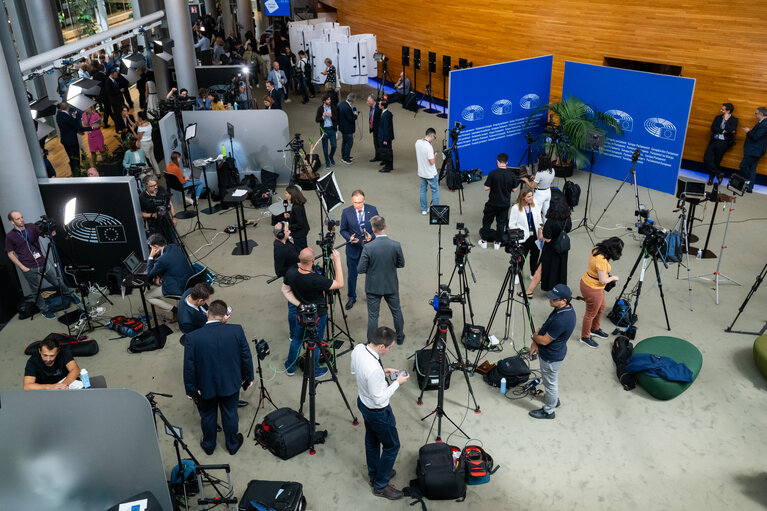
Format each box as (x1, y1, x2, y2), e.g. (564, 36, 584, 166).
(562, 62, 695, 193)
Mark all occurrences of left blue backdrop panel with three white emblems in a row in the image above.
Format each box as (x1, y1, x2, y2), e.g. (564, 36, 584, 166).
(448, 55, 552, 174)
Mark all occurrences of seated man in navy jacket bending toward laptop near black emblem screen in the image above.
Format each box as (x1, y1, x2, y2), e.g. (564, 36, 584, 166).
(146, 234, 194, 323)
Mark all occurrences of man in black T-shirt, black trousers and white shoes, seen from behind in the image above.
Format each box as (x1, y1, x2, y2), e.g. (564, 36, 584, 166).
(479, 153, 519, 250)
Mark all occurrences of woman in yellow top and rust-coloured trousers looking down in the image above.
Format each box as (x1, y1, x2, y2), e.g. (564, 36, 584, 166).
(581, 236, 623, 348)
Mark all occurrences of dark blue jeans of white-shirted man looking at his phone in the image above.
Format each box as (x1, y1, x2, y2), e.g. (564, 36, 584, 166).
(357, 398, 399, 490)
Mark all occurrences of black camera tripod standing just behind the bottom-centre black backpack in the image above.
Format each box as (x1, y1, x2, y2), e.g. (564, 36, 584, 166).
(417, 305, 482, 442)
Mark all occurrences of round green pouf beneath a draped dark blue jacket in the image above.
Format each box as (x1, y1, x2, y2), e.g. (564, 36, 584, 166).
(634, 335, 703, 401)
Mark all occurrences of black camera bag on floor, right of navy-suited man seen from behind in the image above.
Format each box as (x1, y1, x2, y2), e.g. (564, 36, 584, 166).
(256, 408, 328, 460)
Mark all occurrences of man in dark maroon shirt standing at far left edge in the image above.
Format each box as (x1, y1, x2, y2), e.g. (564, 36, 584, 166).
(5, 210, 80, 319)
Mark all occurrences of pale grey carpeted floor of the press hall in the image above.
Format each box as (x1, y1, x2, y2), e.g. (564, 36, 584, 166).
(0, 87, 767, 510)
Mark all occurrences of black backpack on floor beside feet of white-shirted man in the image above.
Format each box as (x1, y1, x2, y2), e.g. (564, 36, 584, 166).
(410, 442, 466, 502)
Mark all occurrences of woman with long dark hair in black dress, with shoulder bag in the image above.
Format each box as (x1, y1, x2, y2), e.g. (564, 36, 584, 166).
(527, 193, 573, 296)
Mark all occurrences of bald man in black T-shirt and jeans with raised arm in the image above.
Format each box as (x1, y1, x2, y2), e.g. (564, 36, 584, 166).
(282, 247, 344, 377)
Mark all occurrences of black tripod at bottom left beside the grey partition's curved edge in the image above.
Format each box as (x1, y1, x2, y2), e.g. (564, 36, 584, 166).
(145, 392, 237, 511)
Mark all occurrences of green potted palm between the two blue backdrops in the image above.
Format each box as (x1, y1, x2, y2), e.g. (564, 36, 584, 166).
(525, 96, 623, 175)
